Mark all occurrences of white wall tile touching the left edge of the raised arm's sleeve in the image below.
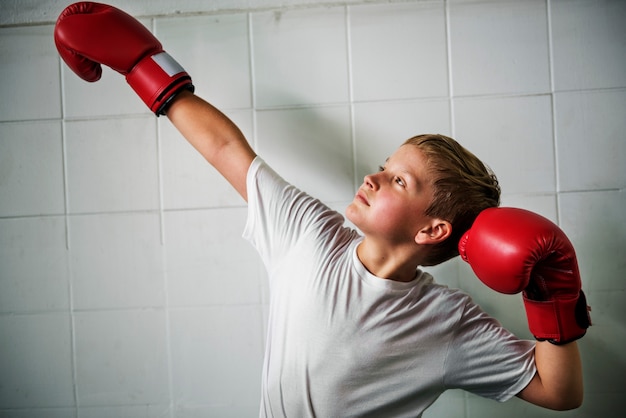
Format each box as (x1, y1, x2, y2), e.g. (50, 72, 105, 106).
(164, 208, 261, 307)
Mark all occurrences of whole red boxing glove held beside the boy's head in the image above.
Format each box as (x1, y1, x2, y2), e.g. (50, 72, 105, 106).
(459, 208, 591, 344)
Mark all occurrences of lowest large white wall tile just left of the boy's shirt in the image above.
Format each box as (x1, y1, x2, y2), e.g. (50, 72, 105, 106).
(171, 305, 263, 418)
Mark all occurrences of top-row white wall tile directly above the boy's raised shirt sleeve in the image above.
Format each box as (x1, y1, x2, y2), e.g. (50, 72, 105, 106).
(251, 7, 349, 107)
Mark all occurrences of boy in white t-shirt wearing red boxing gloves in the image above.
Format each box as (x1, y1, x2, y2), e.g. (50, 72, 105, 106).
(55, 3, 588, 418)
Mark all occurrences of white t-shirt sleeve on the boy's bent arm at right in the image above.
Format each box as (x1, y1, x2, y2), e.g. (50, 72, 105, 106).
(438, 298, 537, 402)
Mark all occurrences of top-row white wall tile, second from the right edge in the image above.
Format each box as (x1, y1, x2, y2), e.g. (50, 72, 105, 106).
(449, 0, 550, 96)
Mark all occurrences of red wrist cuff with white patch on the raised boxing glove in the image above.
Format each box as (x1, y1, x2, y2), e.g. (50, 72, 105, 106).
(126, 52, 194, 116)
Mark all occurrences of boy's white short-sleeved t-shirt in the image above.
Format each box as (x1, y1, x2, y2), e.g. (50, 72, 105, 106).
(244, 157, 536, 418)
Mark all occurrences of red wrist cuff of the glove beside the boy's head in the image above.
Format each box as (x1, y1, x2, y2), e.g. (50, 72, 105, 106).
(524, 290, 591, 344)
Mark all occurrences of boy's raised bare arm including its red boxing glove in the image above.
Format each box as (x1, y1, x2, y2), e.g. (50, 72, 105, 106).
(54, 2, 255, 200)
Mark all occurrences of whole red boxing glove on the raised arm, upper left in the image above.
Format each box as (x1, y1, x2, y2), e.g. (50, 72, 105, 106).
(54, 2, 194, 115)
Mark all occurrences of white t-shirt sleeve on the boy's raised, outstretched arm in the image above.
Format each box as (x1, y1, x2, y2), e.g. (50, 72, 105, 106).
(243, 157, 344, 268)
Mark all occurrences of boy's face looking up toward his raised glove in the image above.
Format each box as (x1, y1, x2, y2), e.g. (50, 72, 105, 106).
(346, 145, 433, 245)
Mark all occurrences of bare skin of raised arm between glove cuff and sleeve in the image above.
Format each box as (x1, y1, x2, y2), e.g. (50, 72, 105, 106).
(167, 91, 256, 200)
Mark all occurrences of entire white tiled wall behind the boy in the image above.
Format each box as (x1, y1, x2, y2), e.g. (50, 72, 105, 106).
(0, 0, 626, 418)
